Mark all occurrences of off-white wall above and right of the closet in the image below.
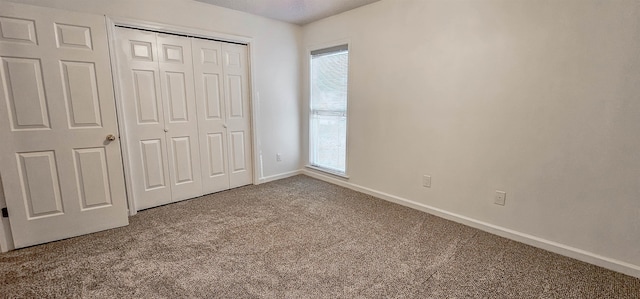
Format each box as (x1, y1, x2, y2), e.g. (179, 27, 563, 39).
(0, 0, 301, 250)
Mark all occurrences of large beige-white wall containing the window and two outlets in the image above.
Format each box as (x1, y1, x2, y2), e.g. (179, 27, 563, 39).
(301, 0, 640, 275)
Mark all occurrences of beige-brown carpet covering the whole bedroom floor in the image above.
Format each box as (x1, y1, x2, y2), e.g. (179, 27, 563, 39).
(0, 176, 640, 298)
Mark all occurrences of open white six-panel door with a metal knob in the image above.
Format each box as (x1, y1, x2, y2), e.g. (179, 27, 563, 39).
(0, 2, 128, 248)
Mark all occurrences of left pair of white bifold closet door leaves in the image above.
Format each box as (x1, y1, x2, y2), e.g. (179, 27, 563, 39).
(117, 28, 202, 209)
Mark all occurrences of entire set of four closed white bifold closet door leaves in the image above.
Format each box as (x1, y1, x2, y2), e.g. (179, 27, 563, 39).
(116, 28, 253, 210)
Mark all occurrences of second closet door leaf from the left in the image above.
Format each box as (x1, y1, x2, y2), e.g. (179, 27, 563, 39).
(157, 34, 202, 201)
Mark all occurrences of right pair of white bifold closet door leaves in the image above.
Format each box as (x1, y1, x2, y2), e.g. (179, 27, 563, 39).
(192, 38, 253, 193)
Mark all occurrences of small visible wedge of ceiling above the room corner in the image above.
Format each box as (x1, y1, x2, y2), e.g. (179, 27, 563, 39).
(196, 0, 380, 25)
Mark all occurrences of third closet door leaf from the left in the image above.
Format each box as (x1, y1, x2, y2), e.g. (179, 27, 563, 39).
(191, 39, 229, 194)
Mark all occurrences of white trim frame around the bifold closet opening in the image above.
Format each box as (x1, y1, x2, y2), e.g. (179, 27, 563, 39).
(106, 16, 262, 216)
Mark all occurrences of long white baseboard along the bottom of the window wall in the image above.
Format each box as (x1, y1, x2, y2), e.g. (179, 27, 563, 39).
(302, 169, 640, 278)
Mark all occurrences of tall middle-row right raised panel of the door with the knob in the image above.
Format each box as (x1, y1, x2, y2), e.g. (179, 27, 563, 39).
(60, 61, 102, 128)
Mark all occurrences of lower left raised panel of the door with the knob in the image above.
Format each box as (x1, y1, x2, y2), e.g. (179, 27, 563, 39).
(16, 151, 64, 220)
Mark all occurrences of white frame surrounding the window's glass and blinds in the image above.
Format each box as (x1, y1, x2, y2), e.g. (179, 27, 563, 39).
(306, 41, 352, 179)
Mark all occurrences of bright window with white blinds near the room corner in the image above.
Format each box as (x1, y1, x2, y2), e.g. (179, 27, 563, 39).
(309, 45, 349, 175)
